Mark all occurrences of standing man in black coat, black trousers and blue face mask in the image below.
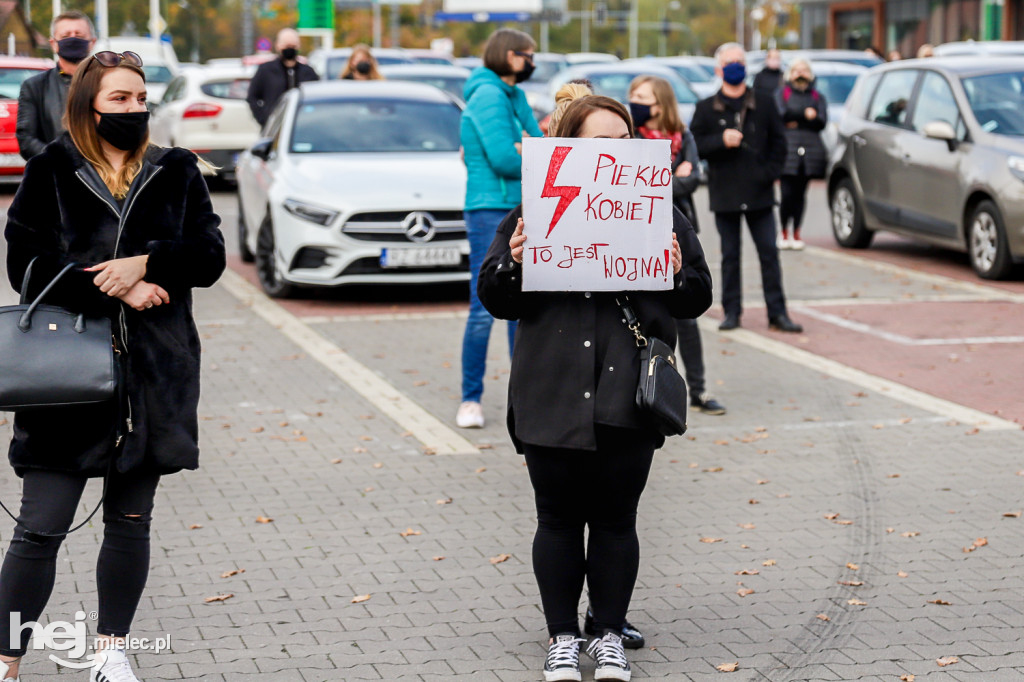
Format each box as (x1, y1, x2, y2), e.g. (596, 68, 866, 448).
(690, 43, 804, 332)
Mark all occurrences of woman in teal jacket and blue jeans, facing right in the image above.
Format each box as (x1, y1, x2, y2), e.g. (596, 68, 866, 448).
(456, 29, 544, 428)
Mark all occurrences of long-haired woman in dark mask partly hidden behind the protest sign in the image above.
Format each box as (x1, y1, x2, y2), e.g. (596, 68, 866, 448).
(630, 76, 725, 415)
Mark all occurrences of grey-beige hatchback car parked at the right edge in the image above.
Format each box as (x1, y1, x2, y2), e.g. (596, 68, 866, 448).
(828, 56, 1024, 280)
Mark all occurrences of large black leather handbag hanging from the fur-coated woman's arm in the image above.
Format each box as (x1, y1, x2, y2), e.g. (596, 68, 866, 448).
(0, 263, 119, 412)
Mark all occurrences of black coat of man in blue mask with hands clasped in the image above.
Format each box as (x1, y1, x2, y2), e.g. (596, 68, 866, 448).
(690, 88, 785, 213)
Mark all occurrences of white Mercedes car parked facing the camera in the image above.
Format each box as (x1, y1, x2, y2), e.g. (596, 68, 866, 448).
(238, 81, 469, 297)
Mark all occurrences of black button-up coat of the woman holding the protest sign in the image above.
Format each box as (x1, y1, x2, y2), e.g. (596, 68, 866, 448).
(476, 206, 712, 453)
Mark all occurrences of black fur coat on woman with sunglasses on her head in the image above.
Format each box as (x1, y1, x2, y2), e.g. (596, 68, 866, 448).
(4, 133, 224, 476)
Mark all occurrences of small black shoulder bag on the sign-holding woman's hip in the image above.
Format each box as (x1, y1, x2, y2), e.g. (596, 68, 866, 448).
(615, 296, 686, 436)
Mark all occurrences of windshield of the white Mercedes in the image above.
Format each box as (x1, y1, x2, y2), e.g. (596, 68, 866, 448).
(292, 99, 461, 154)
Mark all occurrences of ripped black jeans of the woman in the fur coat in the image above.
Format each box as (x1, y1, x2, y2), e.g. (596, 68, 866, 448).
(0, 469, 160, 656)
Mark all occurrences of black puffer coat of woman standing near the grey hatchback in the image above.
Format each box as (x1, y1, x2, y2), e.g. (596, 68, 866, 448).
(775, 84, 828, 177)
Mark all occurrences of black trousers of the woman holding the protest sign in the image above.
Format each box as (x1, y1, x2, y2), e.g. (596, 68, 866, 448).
(524, 426, 654, 637)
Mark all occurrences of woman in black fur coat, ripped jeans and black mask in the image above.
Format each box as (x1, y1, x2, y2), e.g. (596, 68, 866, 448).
(0, 52, 224, 682)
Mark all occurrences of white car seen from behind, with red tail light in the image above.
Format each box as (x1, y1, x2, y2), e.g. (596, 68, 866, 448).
(150, 67, 259, 179)
